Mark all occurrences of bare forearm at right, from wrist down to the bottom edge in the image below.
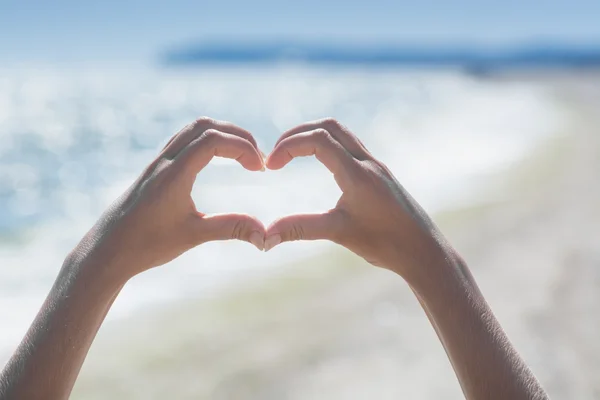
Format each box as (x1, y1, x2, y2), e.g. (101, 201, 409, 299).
(409, 251, 547, 400)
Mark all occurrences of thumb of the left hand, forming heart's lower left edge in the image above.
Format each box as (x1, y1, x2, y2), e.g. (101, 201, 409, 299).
(195, 214, 265, 251)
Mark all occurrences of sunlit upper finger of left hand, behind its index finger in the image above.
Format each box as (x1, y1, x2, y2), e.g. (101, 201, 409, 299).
(161, 117, 260, 159)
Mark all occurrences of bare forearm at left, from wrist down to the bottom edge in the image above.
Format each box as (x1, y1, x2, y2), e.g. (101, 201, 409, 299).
(0, 257, 122, 400)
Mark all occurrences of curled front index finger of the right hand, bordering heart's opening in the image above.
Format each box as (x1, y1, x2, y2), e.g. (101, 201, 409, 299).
(266, 129, 357, 190)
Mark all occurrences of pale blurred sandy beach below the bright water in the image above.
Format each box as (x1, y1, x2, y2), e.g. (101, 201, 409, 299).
(67, 76, 600, 400)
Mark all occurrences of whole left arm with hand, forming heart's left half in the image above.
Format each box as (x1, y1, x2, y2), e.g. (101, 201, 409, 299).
(0, 118, 265, 400)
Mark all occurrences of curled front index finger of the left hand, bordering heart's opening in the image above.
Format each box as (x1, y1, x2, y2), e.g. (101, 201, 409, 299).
(174, 129, 263, 179)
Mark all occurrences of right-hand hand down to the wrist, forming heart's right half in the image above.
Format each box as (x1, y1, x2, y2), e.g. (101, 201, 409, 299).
(265, 119, 448, 278)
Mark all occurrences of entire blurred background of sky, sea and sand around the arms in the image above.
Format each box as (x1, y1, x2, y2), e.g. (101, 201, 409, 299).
(0, 0, 600, 399)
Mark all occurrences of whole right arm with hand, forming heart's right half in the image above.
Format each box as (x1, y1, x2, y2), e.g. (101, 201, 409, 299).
(265, 119, 547, 400)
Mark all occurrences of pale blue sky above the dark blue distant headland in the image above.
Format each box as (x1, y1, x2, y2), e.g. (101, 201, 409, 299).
(0, 0, 600, 64)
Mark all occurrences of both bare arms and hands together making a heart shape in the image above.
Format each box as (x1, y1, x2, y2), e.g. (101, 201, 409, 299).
(0, 118, 547, 400)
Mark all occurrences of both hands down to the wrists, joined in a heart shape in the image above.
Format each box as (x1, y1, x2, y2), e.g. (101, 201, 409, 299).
(75, 118, 444, 286)
